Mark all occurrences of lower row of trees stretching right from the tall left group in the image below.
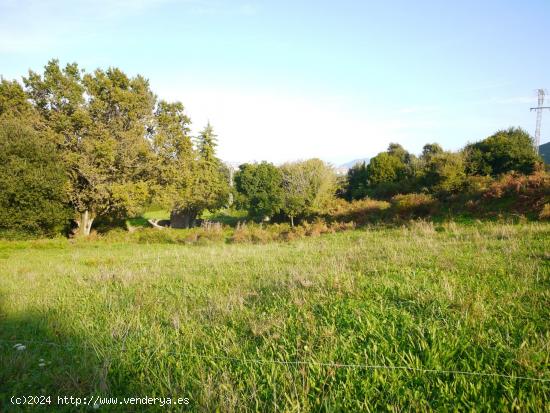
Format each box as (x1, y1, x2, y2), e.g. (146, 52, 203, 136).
(230, 128, 544, 225)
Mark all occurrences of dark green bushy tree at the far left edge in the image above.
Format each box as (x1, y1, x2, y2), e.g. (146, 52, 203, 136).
(0, 117, 69, 235)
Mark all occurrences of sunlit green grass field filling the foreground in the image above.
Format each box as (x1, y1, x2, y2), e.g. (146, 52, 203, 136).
(0, 222, 550, 412)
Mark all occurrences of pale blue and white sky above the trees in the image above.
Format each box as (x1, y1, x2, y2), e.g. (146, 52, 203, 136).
(0, 0, 550, 165)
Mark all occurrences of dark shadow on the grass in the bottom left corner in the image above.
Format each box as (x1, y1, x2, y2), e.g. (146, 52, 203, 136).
(0, 295, 194, 413)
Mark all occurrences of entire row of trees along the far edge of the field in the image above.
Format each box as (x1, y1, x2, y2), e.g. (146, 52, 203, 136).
(0, 60, 542, 235)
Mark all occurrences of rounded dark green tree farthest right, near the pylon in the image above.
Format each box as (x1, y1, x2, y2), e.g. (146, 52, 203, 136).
(465, 128, 541, 176)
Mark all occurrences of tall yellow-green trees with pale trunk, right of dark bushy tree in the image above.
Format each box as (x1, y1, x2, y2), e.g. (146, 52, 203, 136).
(13, 60, 233, 235)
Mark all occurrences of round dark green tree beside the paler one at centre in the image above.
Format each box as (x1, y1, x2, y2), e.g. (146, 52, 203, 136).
(234, 162, 284, 220)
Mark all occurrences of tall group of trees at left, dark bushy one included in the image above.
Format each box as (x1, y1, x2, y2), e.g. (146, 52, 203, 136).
(0, 60, 230, 235)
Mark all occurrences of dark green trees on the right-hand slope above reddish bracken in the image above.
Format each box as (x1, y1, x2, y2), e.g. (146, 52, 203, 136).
(343, 127, 544, 200)
